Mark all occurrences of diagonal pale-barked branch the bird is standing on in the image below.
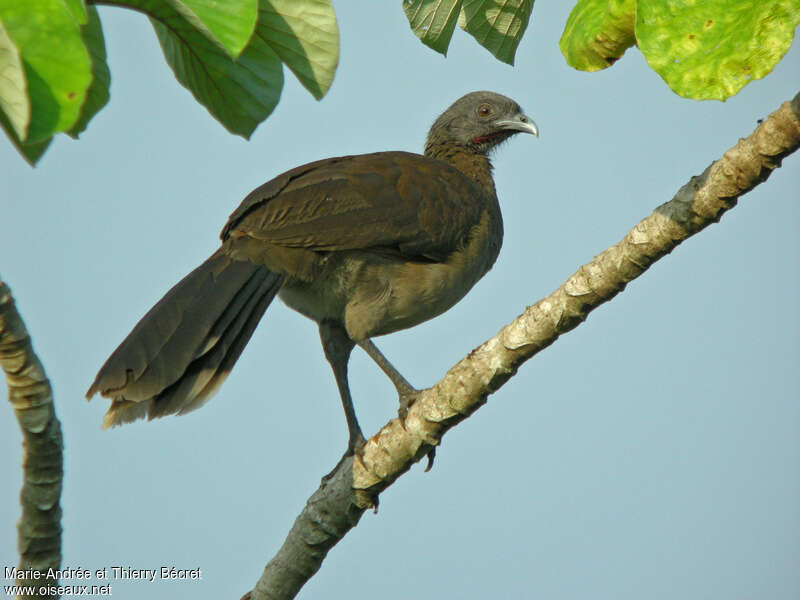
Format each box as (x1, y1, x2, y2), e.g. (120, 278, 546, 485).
(242, 93, 800, 600)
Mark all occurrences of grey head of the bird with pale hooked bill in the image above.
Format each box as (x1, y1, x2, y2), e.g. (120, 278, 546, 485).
(426, 92, 539, 154)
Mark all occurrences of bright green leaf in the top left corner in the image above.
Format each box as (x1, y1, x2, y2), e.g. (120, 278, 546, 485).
(0, 0, 92, 142)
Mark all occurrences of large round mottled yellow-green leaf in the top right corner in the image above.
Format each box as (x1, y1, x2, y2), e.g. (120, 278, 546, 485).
(636, 0, 800, 100)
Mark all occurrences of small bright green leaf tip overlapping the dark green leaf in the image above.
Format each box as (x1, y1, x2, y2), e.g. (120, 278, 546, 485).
(166, 0, 258, 58)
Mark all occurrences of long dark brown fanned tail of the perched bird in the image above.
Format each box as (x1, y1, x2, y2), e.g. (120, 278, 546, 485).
(86, 251, 284, 428)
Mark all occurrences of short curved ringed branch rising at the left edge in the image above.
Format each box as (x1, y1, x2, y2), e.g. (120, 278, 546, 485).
(0, 280, 63, 599)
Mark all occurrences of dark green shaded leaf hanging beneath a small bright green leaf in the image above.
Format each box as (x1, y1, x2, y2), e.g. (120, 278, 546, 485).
(152, 19, 283, 138)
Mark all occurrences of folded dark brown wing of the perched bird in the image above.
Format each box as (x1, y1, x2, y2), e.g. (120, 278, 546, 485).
(222, 152, 488, 260)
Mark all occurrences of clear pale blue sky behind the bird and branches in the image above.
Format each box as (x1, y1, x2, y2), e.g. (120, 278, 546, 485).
(0, 2, 800, 600)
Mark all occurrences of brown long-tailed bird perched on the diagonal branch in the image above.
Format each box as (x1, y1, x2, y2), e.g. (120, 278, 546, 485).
(86, 91, 539, 456)
